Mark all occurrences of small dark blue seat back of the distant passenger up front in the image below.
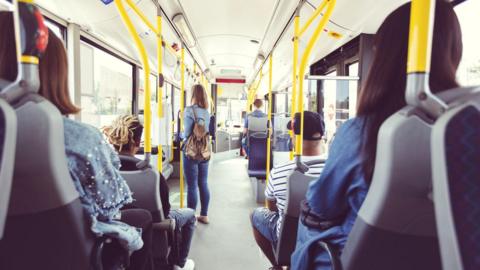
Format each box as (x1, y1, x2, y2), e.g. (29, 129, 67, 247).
(248, 132, 268, 179)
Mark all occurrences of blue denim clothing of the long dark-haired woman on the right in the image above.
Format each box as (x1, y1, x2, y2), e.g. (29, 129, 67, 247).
(292, 118, 368, 270)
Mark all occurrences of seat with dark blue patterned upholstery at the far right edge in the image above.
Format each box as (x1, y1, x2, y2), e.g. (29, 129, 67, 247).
(432, 89, 480, 270)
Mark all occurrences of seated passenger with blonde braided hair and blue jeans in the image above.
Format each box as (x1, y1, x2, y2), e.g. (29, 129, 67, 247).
(103, 115, 196, 269)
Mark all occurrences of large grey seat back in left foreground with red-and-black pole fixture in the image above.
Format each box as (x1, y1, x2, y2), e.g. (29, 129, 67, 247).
(0, 2, 113, 270)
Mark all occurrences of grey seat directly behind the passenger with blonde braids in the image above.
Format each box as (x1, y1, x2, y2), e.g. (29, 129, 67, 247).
(119, 155, 175, 263)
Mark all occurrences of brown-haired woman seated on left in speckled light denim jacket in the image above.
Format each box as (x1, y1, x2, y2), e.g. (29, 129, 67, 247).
(0, 16, 152, 270)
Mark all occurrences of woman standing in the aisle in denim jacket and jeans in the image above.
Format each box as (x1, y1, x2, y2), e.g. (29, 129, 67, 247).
(183, 84, 211, 224)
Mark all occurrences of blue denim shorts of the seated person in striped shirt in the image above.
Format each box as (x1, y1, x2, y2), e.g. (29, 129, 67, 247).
(252, 207, 280, 246)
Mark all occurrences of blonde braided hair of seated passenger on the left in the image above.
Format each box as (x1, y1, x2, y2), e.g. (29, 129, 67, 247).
(102, 115, 142, 152)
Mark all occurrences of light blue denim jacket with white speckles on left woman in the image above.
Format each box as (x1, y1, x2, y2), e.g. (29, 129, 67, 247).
(63, 118, 143, 251)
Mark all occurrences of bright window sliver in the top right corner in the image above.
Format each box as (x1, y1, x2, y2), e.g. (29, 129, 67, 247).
(455, 1, 480, 86)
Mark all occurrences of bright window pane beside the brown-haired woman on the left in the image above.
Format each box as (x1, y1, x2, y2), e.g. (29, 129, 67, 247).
(80, 41, 133, 128)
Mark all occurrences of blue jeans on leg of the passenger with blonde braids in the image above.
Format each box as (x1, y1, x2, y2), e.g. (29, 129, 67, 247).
(168, 208, 196, 267)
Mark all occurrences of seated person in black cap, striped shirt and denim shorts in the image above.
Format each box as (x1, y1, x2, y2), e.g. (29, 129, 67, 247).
(251, 111, 325, 269)
